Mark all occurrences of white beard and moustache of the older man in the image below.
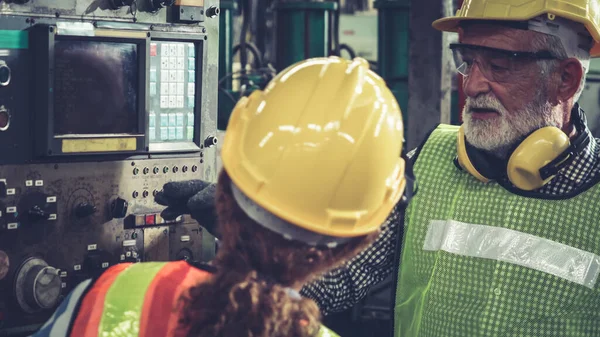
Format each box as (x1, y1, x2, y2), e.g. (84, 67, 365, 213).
(462, 90, 563, 158)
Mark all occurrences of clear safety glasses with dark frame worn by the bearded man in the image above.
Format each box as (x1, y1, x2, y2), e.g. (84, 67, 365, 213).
(450, 43, 558, 83)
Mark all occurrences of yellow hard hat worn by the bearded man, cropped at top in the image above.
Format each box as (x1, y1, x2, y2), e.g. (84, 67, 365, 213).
(433, 0, 600, 57)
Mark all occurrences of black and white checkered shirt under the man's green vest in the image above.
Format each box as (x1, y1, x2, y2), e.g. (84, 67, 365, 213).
(301, 122, 600, 315)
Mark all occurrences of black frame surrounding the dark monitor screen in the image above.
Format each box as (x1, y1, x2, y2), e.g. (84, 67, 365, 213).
(30, 25, 150, 156)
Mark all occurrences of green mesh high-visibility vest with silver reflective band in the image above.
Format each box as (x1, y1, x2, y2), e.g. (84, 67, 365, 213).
(395, 125, 600, 337)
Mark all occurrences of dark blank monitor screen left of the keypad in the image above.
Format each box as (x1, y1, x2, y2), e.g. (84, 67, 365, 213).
(54, 40, 140, 135)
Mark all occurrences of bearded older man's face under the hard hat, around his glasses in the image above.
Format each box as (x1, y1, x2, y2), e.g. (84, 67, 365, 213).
(461, 24, 563, 157)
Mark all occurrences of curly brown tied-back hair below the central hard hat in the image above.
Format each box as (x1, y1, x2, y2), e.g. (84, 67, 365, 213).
(182, 170, 378, 337)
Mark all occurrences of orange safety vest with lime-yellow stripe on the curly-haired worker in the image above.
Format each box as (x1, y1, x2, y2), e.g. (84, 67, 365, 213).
(70, 261, 212, 337)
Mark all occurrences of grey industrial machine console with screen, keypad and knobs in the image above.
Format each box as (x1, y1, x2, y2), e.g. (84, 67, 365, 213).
(0, 0, 220, 336)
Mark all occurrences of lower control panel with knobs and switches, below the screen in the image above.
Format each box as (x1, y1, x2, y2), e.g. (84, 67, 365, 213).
(0, 158, 215, 332)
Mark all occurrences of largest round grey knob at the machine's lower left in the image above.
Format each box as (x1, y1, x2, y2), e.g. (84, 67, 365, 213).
(15, 257, 62, 313)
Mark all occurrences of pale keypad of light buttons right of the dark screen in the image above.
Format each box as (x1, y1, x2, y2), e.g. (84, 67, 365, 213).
(148, 41, 196, 143)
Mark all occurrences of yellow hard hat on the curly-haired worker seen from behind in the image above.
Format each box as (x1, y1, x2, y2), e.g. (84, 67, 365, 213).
(221, 57, 406, 238)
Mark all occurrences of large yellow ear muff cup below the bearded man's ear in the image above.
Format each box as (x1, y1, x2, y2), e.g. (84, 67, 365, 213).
(507, 126, 571, 191)
